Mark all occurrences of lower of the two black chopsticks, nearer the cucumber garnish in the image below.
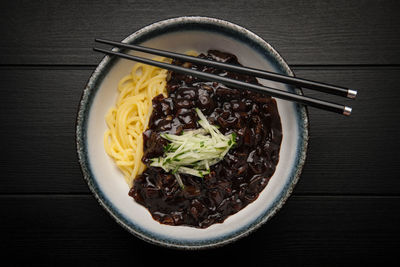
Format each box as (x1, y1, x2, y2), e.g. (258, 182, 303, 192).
(93, 48, 352, 116)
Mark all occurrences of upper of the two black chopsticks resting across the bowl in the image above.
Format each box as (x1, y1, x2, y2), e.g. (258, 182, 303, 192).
(95, 39, 357, 99)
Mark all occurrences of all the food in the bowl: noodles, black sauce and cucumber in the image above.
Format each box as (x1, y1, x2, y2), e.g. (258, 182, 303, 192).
(105, 50, 282, 228)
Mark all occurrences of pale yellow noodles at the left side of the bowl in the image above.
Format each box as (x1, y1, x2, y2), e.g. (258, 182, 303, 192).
(104, 57, 168, 187)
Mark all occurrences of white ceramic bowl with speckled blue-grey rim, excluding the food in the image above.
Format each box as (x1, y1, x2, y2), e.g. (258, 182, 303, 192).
(76, 17, 308, 249)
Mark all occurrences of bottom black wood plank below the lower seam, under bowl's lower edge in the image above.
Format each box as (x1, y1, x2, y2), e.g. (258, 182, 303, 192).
(0, 196, 400, 266)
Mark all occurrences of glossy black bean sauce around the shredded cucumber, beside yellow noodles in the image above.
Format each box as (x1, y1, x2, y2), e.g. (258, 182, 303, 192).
(129, 50, 282, 228)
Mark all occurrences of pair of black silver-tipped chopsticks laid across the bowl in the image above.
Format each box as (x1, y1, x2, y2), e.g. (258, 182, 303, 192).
(93, 39, 357, 116)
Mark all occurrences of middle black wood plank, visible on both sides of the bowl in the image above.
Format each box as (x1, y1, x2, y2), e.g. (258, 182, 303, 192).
(0, 68, 400, 195)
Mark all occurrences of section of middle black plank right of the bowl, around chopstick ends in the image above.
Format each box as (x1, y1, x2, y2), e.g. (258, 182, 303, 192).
(295, 68, 400, 194)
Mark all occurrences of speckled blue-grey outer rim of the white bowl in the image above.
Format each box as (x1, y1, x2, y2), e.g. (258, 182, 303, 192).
(75, 16, 309, 250)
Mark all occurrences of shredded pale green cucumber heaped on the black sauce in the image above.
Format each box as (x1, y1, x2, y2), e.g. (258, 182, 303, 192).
(150, 108, 236, 188)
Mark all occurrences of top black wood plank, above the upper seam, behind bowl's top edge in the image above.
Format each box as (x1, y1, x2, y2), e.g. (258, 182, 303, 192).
(0, 0, 400, 64)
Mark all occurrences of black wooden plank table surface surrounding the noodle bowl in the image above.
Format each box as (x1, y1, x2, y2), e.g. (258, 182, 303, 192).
(0, 0, 400, 266)
